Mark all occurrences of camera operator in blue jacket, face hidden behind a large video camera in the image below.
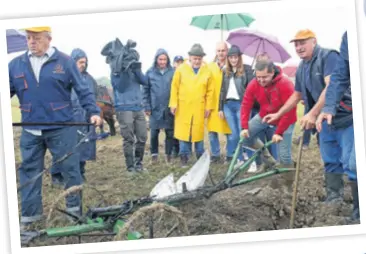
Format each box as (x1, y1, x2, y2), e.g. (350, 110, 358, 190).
(102, 39, 147, 173)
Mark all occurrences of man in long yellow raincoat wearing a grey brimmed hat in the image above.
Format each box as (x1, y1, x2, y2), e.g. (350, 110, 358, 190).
(169, 44, 214, 167)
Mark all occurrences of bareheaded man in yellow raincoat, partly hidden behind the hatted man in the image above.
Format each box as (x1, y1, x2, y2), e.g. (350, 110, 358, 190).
(207, 42, 231, 162)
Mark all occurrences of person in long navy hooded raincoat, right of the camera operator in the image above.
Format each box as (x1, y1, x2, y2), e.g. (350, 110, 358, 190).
(143, 49, 174, 163)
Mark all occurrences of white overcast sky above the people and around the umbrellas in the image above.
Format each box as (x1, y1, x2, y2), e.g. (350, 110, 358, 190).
(9, 3, 347, 78)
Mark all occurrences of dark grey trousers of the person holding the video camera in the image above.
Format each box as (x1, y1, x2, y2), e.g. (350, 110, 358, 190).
(116, 111, 147, 168)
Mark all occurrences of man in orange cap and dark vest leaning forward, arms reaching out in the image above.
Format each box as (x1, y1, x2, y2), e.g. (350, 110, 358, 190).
(263, 30, 344, 202)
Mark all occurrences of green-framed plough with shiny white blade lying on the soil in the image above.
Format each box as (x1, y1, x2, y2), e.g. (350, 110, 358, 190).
(15, 122, 295, 245)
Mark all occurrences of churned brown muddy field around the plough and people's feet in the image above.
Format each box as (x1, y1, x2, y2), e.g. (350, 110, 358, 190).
(14, 117, 358, 246)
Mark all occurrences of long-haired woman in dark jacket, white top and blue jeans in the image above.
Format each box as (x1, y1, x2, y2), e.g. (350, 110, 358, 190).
(218, 45, 254, 165)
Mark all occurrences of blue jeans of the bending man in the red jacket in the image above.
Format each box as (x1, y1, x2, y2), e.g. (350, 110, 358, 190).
(244, 114, 295, 164)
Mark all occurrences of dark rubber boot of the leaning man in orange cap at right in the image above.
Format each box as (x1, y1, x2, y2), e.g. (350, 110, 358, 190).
(325, 173, 344, 203)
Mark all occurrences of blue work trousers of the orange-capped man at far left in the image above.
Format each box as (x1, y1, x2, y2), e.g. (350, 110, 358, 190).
(19, 127, 81, 223)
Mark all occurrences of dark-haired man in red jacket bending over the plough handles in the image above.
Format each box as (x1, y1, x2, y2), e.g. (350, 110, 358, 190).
(241, 60, 297, 169)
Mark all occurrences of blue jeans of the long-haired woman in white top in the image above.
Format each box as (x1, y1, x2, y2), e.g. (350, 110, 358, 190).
(224, 100, 244, 161)
